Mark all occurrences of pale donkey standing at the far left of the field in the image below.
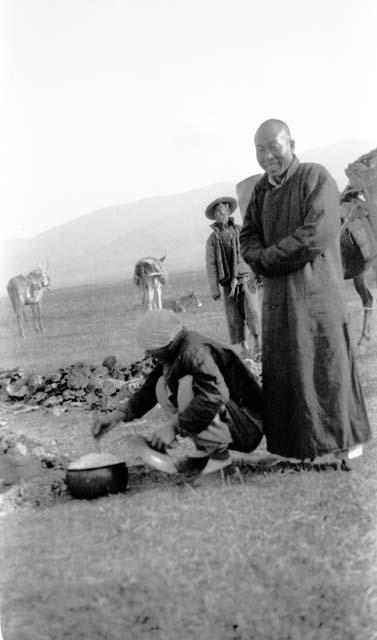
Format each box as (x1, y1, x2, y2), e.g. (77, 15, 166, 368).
(7, 265, 51, 338)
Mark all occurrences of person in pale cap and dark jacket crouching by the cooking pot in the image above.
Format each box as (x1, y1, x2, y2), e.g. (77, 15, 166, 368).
(92, 309, 263, 475)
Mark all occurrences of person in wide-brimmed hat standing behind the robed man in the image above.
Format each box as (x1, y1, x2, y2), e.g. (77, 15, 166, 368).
(205, 196, 261, 360)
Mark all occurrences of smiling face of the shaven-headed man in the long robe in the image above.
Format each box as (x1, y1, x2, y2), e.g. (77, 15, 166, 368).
(255, 125, 294, 178)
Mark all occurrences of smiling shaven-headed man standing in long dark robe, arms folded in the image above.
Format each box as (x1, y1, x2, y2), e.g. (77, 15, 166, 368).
(240, 120, 370, 460)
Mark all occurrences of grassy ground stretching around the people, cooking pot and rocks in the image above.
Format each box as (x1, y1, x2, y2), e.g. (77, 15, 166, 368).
(0, 274, 377, 640)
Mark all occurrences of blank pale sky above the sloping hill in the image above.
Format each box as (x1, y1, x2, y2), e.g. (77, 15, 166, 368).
(0, 0, 377, 237)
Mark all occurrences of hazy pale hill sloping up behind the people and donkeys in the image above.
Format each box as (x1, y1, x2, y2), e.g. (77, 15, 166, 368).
(0, 141, 369, 295)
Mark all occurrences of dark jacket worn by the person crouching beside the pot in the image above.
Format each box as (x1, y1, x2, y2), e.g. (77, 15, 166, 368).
(119, 329, 262, 450)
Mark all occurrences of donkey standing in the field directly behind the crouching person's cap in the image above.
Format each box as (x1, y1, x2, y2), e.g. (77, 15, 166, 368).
(134, 255, 168, 311)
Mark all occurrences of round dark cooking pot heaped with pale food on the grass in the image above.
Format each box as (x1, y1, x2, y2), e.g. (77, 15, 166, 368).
(66, 453, 128, 500)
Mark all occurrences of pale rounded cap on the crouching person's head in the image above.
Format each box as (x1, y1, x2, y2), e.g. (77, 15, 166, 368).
(136, 309, 183, 351)
